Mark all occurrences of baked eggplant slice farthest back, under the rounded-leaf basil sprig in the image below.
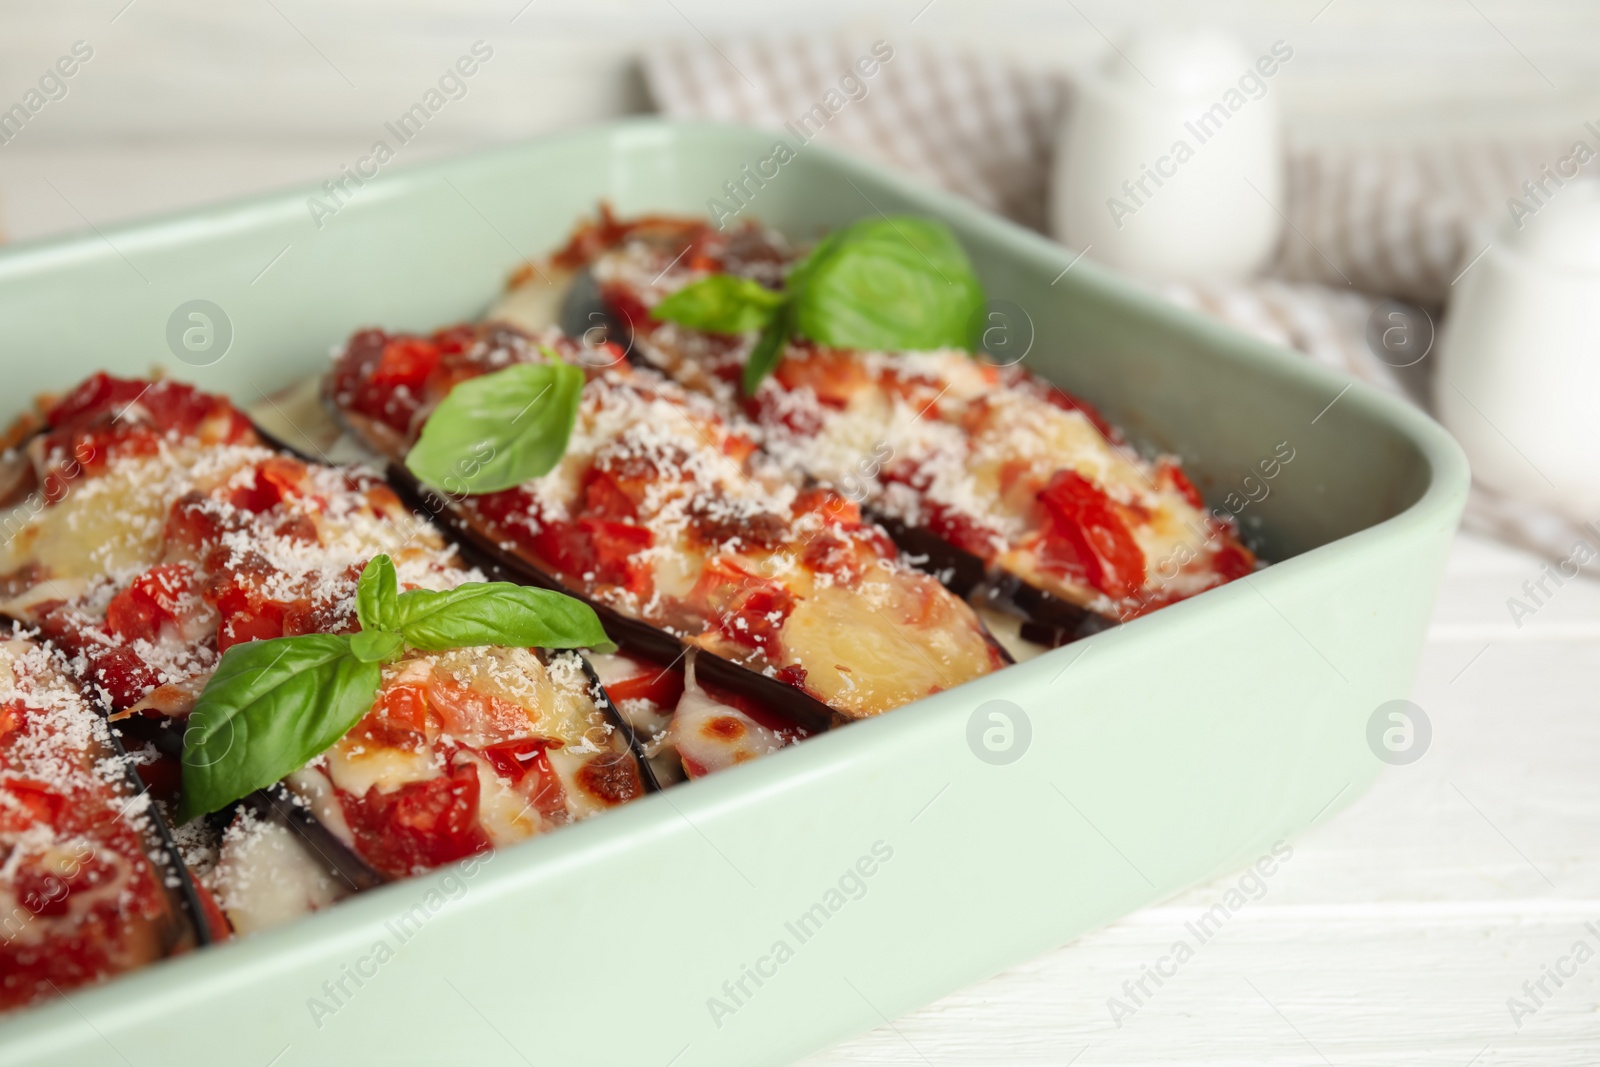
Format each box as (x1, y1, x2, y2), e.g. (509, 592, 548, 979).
(490, 211, 1254, 645)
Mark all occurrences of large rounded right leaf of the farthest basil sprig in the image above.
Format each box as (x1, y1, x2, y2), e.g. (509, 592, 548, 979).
(789, 216, 984, 352)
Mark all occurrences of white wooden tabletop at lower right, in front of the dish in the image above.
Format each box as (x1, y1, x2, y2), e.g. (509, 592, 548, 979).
(806, 534, 1600, 1067)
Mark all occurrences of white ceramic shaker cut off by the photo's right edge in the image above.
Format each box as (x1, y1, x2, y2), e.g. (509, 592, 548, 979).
(1434, 179, 1600, 522)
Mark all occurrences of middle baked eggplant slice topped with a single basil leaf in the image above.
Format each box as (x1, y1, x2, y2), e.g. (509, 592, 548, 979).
(328, 326, 1008, 729)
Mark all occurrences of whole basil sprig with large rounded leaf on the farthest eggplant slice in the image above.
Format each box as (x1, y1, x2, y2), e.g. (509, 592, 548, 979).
(650, 216, 984, 394)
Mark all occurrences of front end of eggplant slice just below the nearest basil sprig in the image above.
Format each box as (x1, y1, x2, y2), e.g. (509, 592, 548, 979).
(288, 648, 645, 878)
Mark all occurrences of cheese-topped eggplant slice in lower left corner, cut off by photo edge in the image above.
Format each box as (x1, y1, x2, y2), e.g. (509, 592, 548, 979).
(0, 635, 210, 1009)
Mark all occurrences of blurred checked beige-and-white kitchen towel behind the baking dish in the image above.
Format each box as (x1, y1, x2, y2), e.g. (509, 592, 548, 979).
(643, 37, 1582, 572)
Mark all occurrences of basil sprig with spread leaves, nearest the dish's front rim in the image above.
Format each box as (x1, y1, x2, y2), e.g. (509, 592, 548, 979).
(179, 555, 616, 822)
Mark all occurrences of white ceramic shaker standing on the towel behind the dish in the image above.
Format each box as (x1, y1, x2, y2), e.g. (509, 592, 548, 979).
(1051, 29, 1294, 280)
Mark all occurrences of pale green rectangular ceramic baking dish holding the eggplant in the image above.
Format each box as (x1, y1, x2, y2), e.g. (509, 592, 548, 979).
(0, 122, 1467, 1067)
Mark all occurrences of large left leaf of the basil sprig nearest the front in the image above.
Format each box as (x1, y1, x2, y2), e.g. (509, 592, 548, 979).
(179, 633, 382, 822)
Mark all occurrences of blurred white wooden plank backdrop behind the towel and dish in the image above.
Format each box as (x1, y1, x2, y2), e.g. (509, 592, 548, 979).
(0, 0, 1600, 240)
